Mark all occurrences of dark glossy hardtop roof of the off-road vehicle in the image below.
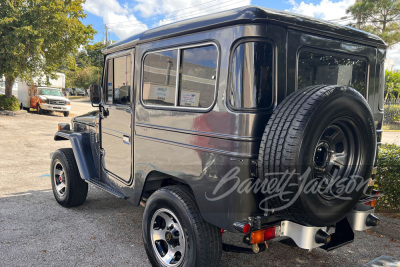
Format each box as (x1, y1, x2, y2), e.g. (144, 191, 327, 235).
(103, 6, 386, 54)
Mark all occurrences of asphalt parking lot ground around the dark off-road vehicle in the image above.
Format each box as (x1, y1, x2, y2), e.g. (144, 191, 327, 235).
(0, 101, 400, 267)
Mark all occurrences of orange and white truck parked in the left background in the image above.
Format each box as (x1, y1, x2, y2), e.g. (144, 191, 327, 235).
(30, 87, 71, 117)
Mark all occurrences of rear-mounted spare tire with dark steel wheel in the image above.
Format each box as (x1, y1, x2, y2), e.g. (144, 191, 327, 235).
(259, 85, 376, 226)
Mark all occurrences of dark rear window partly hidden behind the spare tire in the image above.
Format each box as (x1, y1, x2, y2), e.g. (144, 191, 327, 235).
(298, 51, 367, 96)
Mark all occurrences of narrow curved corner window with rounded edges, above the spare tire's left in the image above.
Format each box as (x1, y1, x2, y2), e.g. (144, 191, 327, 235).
(230, 41, 274, 109)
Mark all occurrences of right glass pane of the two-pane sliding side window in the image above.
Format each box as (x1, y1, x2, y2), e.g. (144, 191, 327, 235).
(179, 45, 218, 108)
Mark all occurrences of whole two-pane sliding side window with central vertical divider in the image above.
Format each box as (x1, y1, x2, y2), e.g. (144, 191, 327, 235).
(142, 45, 218, 109)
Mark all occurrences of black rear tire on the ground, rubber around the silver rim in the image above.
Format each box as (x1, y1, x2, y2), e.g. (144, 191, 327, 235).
(142, 185, 222, 267)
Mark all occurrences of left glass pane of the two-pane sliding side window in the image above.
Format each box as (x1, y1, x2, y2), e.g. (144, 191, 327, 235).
(142, 50, 178, 106)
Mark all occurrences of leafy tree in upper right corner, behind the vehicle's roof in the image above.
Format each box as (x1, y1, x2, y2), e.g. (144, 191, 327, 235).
(347, 0, 400, 46)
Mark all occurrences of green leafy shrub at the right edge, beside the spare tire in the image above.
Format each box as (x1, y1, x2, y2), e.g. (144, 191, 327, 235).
(376, 144, 400, 210)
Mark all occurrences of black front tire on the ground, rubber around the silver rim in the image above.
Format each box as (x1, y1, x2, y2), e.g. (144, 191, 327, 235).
(50, 148, 88, 208)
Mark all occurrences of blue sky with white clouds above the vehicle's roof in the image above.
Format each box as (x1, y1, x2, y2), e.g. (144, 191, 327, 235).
(83, 0, 400, 68)
